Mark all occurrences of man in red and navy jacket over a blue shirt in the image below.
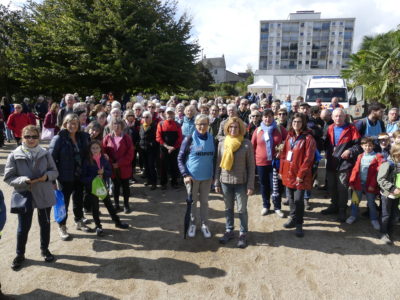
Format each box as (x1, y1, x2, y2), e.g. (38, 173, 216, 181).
(321, 108, 362, 222)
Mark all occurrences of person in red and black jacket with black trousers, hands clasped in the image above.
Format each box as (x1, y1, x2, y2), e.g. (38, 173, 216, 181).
(156, 107, 182, 190)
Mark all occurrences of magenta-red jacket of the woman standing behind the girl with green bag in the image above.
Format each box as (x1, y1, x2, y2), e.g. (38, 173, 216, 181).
(103, 133, 135, 179)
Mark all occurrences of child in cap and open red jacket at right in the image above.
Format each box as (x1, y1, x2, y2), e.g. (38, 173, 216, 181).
(346, 137, 385, 230)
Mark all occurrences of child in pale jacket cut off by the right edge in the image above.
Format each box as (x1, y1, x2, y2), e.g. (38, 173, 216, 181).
(377, 144, 400, 244)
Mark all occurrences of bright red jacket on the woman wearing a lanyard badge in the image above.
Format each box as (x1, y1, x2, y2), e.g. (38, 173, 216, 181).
(279, 131, 317, 190)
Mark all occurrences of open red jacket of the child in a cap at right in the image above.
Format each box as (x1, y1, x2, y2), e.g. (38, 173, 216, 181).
(349, 153, 385, 194)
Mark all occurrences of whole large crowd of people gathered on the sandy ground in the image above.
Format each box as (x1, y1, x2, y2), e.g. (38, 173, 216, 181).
(0, 94, 400, 276)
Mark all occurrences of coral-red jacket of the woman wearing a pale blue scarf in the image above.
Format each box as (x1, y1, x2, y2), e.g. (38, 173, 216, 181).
(251, 125, 287, 166)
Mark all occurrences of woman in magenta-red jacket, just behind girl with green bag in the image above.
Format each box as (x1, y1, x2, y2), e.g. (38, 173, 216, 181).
(103, 119, 134, 214)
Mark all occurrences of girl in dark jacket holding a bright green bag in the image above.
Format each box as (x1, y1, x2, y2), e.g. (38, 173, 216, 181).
(82, 140, 128, 236)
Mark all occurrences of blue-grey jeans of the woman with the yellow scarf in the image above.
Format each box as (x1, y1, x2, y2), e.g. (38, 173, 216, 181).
(221, 183, 248, 233)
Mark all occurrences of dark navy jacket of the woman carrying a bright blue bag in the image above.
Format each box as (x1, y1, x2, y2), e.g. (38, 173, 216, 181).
(49, 129, 89, 182)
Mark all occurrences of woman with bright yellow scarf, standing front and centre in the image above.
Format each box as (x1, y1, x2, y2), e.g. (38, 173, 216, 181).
(215, 117, 255, 248)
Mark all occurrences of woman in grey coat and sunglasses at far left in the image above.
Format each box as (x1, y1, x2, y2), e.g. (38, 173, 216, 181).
(4, 125, 58, 270)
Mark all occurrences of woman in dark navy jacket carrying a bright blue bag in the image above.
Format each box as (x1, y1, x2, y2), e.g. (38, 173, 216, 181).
(49, 114, 91, 241)
